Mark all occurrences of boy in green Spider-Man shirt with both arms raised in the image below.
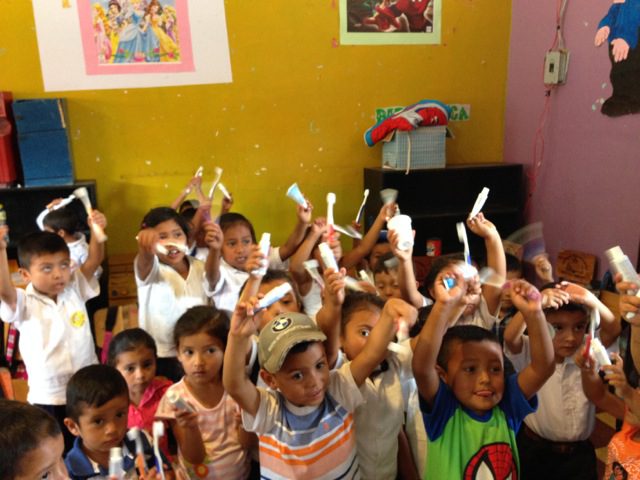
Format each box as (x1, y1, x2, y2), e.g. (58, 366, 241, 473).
(413, 269, 553, 478)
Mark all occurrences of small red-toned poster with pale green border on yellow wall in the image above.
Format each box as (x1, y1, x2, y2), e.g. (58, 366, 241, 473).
(340, 0, 441, 45)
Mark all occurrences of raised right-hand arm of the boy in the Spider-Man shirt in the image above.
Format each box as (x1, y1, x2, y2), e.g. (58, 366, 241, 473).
(510, 280, 555, 398)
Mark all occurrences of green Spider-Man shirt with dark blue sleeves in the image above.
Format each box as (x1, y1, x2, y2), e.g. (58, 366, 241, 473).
(420, 374, 538, 480)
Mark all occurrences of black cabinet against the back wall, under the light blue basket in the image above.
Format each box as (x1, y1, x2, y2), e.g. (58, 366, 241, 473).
(364, 164, 525, 258)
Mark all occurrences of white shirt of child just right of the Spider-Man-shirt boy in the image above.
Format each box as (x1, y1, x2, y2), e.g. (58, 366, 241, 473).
(505, 335, 596, 442)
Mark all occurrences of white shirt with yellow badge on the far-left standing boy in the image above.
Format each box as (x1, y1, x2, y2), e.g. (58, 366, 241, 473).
(0, 270, 100, 405)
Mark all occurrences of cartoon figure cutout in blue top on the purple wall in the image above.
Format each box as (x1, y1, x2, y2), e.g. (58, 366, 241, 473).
(595, 0, 640, 117)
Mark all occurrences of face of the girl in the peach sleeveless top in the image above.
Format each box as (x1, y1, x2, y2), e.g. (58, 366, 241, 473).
(178, 332, 224, 386)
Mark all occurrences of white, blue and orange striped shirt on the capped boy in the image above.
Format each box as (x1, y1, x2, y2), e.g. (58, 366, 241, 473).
(242, 363, 363, 479)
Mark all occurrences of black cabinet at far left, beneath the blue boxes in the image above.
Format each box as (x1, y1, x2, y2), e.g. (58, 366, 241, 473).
(0, 180, 97, 258)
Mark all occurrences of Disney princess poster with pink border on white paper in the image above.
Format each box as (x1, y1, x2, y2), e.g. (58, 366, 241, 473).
(33, 0, 231, 91)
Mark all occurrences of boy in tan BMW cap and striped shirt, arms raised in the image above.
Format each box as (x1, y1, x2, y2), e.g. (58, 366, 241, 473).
(223, 299, 417, 479)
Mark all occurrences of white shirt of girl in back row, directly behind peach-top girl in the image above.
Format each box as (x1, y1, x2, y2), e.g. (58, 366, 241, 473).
(134, 255, 211, 358)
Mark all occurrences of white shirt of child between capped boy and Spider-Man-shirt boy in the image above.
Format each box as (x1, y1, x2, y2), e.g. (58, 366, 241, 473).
(342, 339, 413, 480)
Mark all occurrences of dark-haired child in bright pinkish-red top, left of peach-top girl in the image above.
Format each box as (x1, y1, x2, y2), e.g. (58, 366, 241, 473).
(107, 328, 171, 442)
